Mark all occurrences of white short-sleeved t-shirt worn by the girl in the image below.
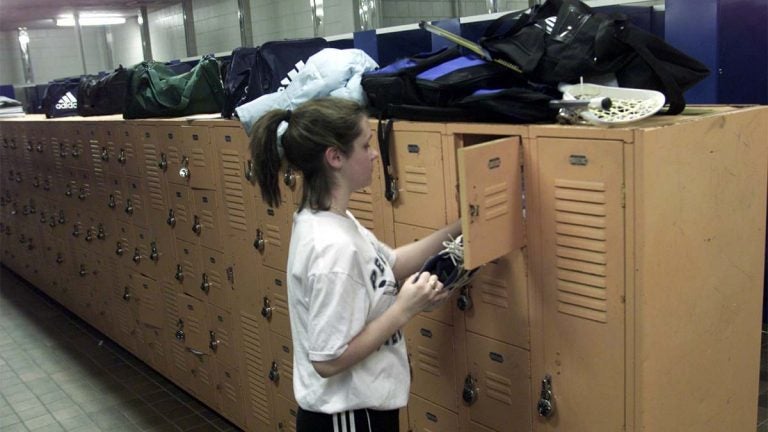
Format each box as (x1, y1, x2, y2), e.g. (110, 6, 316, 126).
(287, 209, 410, 414)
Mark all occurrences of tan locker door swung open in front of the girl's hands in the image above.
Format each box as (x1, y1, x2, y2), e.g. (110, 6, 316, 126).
(458, 137, 525, 269)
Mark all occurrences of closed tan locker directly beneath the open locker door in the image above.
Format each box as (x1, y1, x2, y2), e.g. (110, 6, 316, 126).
(464, 250, 531, 349)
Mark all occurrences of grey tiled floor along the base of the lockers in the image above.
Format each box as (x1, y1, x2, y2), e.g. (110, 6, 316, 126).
(0, 266, 768, 432)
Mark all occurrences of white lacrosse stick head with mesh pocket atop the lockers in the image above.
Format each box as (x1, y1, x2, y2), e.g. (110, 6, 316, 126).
(549, 84, 665, 126)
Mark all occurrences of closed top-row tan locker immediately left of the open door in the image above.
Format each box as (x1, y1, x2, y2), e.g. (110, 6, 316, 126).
(390, 128, 448, 229)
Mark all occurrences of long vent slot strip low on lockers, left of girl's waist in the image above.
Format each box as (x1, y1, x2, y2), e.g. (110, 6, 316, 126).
(240, 312, 272, 425)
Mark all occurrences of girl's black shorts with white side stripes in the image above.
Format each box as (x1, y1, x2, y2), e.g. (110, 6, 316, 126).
(296, 407, 400, 432)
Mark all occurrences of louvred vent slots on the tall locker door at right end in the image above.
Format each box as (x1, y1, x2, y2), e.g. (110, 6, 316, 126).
(555, 179, 608, 323)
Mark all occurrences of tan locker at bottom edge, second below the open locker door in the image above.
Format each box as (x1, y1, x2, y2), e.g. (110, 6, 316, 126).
(462, 333, 532, 431)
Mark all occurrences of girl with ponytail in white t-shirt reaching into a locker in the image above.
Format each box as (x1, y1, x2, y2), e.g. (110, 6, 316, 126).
(251, 98, 460, 432)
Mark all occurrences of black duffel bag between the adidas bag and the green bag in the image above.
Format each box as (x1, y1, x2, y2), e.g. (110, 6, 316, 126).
(77, 65, 131, 117)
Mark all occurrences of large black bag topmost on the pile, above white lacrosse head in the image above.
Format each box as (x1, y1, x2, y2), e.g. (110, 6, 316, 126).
(480, 0, 709, 114)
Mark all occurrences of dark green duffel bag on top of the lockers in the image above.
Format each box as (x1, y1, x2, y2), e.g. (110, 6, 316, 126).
(123, 56, 224, 119)
